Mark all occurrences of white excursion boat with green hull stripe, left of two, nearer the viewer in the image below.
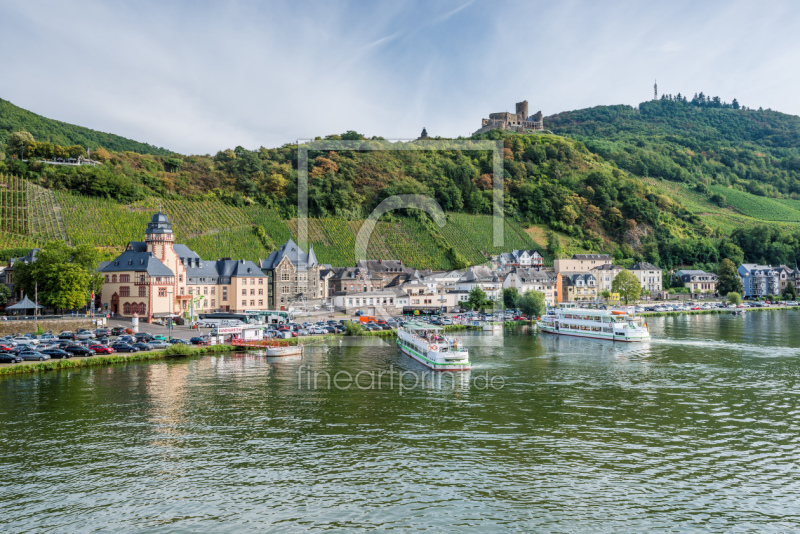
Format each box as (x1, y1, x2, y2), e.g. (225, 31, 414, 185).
(397, 323, 471, 371)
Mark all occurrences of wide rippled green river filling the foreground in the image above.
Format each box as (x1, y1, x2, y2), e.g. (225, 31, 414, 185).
(0, 311, 800, 533)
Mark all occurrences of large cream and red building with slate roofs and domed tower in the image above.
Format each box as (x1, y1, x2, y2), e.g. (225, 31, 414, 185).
(98, 212, 269, 321)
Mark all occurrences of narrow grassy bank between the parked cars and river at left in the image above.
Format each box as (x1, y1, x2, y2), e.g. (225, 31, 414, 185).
(0, 345, 236, 375)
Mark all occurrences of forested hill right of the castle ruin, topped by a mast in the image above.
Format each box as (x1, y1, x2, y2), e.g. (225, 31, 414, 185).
(545, 98, 800, 198)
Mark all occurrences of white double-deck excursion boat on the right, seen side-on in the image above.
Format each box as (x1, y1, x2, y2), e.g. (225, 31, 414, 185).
(536, 302, 650, 342)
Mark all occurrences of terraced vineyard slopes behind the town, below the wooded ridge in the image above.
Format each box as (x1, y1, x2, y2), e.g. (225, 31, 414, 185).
(0, 176, 546, 269)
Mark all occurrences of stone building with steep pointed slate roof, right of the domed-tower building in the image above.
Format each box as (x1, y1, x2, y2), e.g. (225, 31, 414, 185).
(259, 239, 324, 311)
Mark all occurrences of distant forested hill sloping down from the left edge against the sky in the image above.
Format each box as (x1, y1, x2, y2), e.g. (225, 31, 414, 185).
(0, 99, 171, 155)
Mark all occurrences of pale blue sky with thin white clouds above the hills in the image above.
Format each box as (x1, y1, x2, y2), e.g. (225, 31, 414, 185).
(0, 0, 800, 154)
